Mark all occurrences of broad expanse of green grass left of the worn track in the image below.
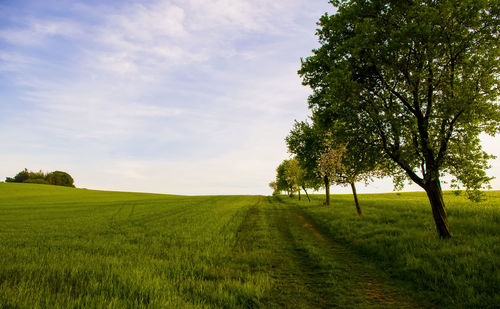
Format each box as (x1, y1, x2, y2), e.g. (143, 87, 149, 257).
(0, 183, 268, 308)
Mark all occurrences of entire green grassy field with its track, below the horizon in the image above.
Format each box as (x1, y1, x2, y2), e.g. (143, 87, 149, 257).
(0, 183, 500, 308)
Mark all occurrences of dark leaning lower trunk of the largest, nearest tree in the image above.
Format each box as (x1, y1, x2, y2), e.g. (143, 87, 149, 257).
(424, 177, 451, 238)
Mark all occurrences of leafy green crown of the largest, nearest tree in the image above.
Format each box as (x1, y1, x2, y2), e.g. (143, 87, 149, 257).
(299, 0, 500, 196)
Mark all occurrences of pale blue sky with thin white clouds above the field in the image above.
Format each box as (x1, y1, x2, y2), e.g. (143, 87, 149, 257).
(0, 0, 500, 194)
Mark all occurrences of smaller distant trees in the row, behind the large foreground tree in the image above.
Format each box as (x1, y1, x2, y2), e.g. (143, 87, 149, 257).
(270, 121, 376, 215)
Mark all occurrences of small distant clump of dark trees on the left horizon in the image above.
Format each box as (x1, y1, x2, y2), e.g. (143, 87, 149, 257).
(5, 169, 75, 187)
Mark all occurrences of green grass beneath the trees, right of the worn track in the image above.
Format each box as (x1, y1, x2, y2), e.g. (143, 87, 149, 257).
(290, 192, 500, 308)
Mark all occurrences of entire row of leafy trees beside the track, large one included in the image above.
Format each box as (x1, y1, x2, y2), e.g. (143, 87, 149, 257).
(270, 0, 500, 238)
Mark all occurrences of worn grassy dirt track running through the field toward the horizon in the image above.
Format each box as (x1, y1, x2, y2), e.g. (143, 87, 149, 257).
(234, 198, 422, 308)
